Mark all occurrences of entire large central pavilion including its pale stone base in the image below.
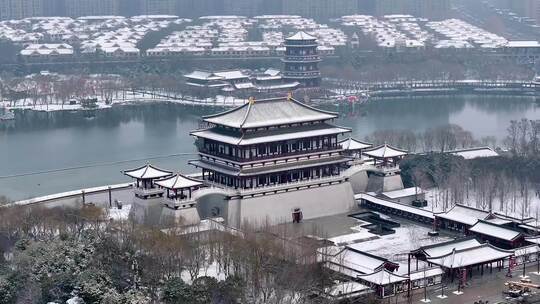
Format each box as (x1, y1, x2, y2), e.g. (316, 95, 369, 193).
(190, 96, 354, 223)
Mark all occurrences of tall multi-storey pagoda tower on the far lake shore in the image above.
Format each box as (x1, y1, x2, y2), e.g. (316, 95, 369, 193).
(282, 32, 321, 87)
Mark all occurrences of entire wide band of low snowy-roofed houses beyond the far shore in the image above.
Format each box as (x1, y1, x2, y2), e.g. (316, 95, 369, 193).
(0, 12, 540, 62)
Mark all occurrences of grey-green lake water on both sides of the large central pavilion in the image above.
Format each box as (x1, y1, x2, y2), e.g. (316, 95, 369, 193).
(0, 96, 540, 200)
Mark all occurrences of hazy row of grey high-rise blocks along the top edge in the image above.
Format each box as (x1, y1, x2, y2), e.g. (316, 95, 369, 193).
(0, 0, 456, 20)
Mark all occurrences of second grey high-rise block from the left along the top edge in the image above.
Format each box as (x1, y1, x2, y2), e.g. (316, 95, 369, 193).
(64, 0, 120, 17)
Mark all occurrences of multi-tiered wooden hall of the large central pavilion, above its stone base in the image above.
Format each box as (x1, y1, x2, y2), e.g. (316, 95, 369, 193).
(190, 97, 350, 189)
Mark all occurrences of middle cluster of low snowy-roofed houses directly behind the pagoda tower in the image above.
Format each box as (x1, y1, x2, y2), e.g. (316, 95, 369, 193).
(147, 15, 347, 57)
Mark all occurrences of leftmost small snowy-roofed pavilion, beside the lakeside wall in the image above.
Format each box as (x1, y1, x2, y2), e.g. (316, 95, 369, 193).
(124, 164, 173, 199)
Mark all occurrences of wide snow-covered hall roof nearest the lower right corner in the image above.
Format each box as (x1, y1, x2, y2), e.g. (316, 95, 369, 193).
(427, 243, 514, 268)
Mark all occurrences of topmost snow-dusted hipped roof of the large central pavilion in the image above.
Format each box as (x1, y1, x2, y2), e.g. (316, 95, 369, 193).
(203, 98, 338, 129)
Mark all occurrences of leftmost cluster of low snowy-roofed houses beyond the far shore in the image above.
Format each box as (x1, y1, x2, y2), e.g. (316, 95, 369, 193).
(0, 15, 191, 61)
